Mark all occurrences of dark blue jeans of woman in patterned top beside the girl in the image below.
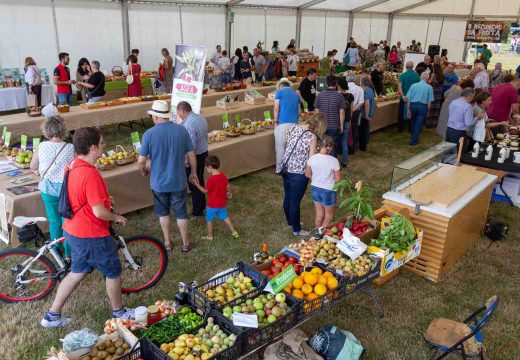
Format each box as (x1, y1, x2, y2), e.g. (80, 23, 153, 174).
(282, 173, 309, 232)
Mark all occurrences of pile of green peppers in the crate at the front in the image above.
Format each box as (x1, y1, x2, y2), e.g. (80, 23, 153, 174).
(135, 307, 204, 345)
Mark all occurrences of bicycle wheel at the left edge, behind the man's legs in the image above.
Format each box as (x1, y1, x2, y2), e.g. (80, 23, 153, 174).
(0, 249, 57, 303)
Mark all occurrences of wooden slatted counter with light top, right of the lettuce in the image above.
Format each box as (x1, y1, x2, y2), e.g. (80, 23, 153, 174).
(383, 165, 497, 282)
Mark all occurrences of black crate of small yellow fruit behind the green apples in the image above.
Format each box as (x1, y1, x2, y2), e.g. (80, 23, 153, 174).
(188, 261, 267, 311)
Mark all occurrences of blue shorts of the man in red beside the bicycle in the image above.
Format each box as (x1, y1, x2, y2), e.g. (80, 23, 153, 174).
(65, 234, 121, 279)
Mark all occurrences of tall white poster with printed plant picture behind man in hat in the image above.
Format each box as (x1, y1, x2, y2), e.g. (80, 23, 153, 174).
(171, 45, 206, 118)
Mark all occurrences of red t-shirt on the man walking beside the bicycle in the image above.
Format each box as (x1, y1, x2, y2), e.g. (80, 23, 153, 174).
(63, 158, 110, 238)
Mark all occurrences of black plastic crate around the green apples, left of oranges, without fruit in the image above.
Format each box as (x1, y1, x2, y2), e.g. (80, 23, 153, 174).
(217, 291, 302, 354)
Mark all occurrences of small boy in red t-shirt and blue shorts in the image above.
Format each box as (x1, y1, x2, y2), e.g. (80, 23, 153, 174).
(193, 156, 240, 240)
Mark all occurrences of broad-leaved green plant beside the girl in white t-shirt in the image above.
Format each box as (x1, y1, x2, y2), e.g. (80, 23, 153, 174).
(334, 179, 374, 226)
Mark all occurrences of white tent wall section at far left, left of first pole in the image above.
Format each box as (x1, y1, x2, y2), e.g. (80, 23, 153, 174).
(0, 0, 58, 73)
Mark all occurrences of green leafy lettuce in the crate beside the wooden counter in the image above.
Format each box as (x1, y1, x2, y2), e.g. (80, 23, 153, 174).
(372, 214, 415, 252)
